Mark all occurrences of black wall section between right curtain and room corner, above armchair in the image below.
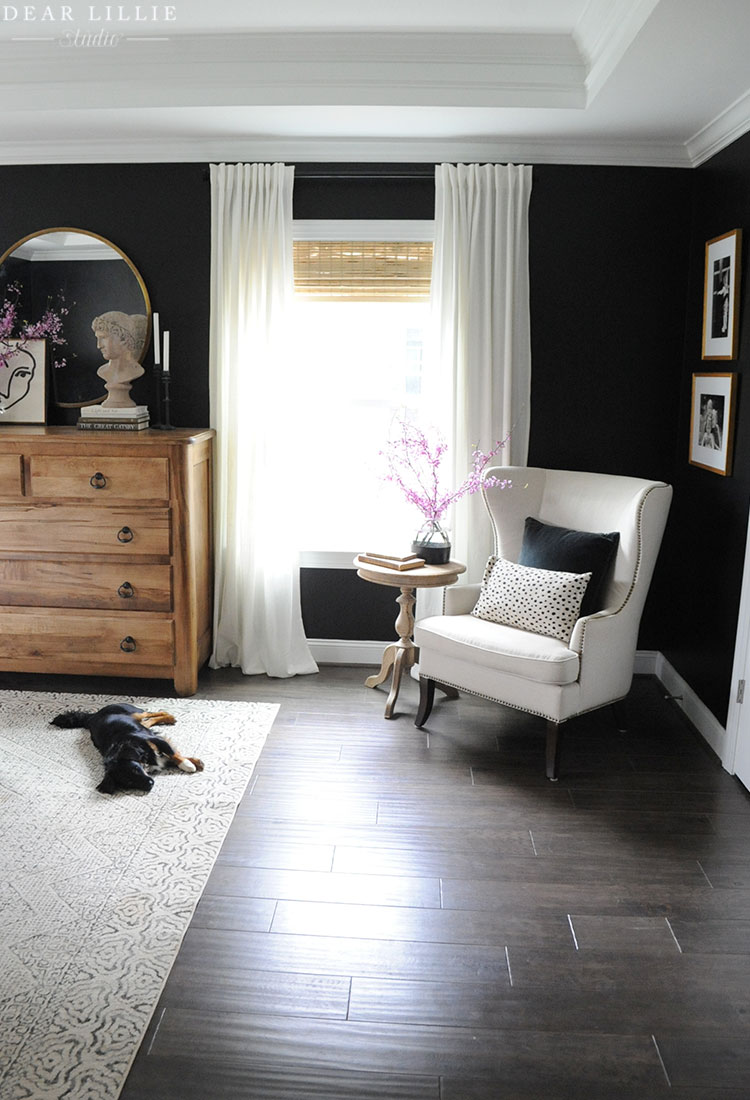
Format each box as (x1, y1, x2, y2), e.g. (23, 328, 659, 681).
(529, 165, 691, 480)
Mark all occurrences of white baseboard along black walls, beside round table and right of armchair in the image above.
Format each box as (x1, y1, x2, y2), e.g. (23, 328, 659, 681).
(308, 638, 727, 760)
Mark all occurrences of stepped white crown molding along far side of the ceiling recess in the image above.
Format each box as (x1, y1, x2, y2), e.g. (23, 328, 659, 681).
(0, 32, 586, 110)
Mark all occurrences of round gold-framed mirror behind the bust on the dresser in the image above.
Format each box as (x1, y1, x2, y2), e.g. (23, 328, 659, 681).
(0, 227, 152, 408)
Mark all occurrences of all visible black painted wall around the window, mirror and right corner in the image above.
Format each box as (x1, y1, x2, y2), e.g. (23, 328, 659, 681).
(0, 152, 750, 704)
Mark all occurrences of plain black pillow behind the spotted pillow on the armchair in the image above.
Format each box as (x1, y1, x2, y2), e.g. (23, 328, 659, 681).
(518, 516, 620, 616)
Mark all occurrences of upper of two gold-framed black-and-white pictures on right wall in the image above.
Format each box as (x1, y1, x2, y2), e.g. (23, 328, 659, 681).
(702, 229, 742, 359)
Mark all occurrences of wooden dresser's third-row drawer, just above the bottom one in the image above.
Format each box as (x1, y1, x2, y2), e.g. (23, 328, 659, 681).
(0, 558, 172, 612)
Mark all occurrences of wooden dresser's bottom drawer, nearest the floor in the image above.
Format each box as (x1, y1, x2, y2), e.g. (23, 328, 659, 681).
(0, 608, 175, 672)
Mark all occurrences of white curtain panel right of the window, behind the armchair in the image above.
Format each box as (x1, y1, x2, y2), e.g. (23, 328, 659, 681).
(432, 164, 531, 581)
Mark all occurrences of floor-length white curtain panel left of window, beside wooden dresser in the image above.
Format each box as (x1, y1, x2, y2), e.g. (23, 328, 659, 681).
(209, 164, 318, 677)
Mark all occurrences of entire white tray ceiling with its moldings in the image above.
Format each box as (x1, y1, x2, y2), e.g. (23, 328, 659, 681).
(0, 0, 750, 167)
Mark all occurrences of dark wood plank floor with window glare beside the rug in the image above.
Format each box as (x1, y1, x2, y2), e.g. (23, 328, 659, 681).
(7, 667, 750, 1100)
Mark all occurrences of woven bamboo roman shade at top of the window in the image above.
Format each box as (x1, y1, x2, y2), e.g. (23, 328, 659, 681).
(294, 241, 432, 301)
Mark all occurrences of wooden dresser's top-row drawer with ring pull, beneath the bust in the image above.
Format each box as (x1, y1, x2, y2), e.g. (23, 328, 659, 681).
(29, 454, 169, 504)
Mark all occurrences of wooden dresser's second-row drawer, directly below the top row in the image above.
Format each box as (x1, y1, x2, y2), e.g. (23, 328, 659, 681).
(0, 504, 170, 557)
